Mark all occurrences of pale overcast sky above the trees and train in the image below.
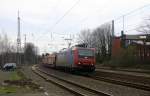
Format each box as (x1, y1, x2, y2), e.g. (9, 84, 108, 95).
(0, 0, 150, 53)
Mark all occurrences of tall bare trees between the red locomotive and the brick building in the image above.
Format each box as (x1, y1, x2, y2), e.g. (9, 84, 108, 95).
(78, 24, 112, 61)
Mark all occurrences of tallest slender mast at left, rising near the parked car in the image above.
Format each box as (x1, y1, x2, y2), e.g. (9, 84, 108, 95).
(17, 11, 21, 66)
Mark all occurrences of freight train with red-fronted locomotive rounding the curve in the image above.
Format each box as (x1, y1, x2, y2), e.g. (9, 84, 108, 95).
(42, 47, 96, 72)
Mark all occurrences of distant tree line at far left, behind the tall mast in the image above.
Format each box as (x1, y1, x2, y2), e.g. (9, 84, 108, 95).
(0, 34, 38, 67)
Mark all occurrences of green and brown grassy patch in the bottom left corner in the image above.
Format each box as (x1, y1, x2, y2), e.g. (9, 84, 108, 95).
(0, 70, 44, 95)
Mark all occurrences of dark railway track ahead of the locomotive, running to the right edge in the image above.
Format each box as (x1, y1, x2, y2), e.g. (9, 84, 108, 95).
(88, 72, 150, 91)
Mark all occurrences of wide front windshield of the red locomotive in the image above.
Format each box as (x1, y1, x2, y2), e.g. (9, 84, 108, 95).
(78, 49, 94, 57)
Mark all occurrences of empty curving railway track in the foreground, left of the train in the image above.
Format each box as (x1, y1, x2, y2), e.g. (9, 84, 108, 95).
(32, 66, 111, 96)
